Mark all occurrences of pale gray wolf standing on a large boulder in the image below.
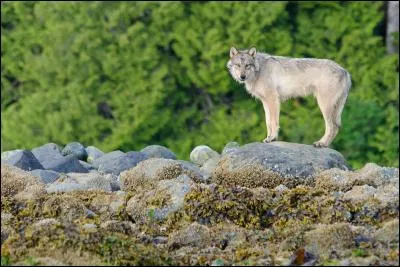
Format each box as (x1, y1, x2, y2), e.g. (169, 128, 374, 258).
(227, 47, 351, 147)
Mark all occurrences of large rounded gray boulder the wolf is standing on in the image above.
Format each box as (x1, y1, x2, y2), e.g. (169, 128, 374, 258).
(212, 142, 350, 188)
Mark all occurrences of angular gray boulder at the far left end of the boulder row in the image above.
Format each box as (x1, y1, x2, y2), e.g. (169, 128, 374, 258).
(1, 149, 43, 171)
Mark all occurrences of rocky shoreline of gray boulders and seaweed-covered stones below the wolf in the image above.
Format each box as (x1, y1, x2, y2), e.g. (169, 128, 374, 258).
(1, 142, 399, 266)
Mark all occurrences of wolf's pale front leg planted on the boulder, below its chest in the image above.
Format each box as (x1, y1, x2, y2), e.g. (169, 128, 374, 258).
(262, 98, 280, 143)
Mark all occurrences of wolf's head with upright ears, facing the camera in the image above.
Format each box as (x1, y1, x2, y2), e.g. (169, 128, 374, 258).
(227, 47, 259, 83)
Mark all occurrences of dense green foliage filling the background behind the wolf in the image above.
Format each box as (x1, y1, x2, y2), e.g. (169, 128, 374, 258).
(1, 2, 399, 168)
